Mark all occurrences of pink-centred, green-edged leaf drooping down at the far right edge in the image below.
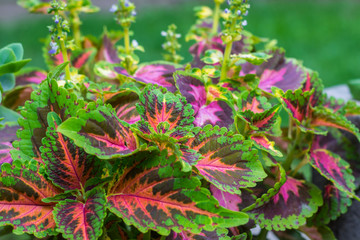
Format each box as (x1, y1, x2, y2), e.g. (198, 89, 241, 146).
(310, 140, 357, 198)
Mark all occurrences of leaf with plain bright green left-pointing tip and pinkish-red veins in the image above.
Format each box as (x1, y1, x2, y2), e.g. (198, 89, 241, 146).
(58, 103, 138, 159)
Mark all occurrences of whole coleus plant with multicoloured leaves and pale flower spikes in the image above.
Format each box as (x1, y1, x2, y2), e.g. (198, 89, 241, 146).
(0, 0, 360, 240)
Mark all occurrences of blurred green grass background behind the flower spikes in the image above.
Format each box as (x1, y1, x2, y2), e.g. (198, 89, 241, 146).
(0, 0, 360, 86)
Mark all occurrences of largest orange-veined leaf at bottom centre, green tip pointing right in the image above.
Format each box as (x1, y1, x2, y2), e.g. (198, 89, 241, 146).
(108, 152, 248, 235)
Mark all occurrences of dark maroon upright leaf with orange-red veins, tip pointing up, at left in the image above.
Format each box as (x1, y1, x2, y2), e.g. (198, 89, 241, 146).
(40, 114, 97, 190)
